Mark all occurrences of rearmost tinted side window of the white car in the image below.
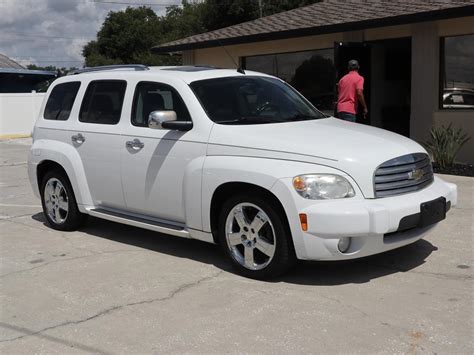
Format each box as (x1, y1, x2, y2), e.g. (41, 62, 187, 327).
(43, 81, 81, 121)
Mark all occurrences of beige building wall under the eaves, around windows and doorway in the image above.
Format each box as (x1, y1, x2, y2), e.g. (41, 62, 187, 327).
(187, 16, 474, 163)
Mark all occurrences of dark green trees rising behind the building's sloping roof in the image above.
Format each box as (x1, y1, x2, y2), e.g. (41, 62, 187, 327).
(82, 0, 324, 66)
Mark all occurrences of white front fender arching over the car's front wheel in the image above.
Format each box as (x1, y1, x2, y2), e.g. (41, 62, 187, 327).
(201, 156, 352, 232)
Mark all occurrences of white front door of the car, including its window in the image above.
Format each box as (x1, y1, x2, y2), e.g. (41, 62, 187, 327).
(120, 81, 206, 223)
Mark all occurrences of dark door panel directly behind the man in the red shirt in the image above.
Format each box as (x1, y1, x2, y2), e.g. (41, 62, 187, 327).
(334, 42, 372, 124)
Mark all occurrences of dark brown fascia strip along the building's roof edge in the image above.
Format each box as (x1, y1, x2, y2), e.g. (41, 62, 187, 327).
(151, 5, 474, 53)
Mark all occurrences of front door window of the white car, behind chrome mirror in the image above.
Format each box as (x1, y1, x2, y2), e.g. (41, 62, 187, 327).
(132, 81, 191, 127)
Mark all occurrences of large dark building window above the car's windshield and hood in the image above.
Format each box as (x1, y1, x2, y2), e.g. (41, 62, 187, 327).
(243, 49, 336, 112)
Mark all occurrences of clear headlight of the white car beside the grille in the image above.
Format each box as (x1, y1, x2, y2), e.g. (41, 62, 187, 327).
(293, 174, 355, 200)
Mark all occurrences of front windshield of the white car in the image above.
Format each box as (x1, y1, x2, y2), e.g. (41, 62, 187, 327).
(190, 76, 326, 125)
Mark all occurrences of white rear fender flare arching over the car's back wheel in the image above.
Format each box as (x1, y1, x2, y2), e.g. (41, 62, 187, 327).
(31, 139, 93, 212)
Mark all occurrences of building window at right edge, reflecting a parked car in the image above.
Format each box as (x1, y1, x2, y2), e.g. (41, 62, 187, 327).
(440, 34, 474, 109)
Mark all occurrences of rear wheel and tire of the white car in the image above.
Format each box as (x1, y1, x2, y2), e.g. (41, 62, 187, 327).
(40, 170, 87, 231)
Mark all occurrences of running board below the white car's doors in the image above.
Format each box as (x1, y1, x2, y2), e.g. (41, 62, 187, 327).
(88, 208, 191, 238)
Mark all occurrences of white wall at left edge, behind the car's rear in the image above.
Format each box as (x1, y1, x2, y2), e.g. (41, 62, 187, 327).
(0, 93, 45, 136)
